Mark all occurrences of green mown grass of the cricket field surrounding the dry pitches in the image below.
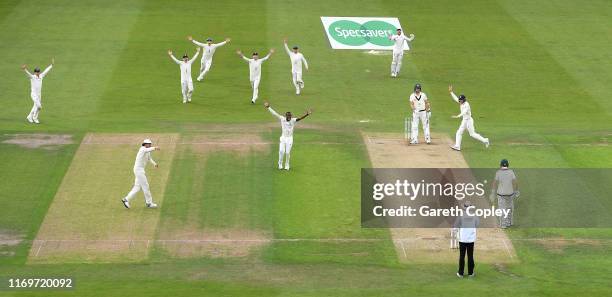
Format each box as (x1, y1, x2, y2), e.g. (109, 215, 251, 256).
(0, 0, 612, 296)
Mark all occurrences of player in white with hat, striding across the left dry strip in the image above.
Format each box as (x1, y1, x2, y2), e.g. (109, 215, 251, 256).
(121, 139, 159, 209)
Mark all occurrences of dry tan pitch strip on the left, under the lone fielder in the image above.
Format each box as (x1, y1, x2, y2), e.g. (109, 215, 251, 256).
(28, 133, 178, 263)
